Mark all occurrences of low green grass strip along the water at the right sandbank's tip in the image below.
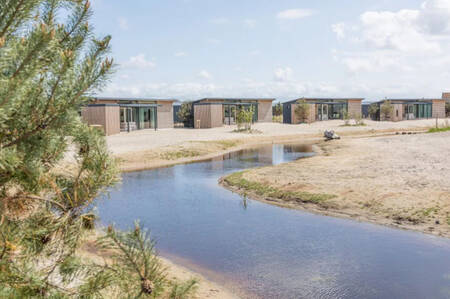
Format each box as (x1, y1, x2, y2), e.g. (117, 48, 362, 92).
(224, 171, 335, 206)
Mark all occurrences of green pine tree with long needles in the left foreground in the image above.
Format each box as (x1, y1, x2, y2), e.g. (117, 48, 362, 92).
(0, 0, 195, 298)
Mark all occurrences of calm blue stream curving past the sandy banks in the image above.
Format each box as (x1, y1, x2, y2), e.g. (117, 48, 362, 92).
(98, 145, 450, 298)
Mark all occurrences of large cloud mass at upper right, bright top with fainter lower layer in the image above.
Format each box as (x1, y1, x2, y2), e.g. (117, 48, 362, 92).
(332, 0, 450, 76)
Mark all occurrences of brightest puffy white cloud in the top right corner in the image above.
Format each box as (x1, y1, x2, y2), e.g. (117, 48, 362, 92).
(332, 0, 450, 55)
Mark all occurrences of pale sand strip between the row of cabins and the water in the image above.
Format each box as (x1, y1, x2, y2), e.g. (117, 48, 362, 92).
(107, 120, 442, 171)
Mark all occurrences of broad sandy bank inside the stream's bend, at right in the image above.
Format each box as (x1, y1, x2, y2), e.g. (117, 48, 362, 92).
(224, 133, 450, 237)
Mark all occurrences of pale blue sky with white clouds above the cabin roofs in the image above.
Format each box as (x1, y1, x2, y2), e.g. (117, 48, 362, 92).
(89, 0, 450, 101)
